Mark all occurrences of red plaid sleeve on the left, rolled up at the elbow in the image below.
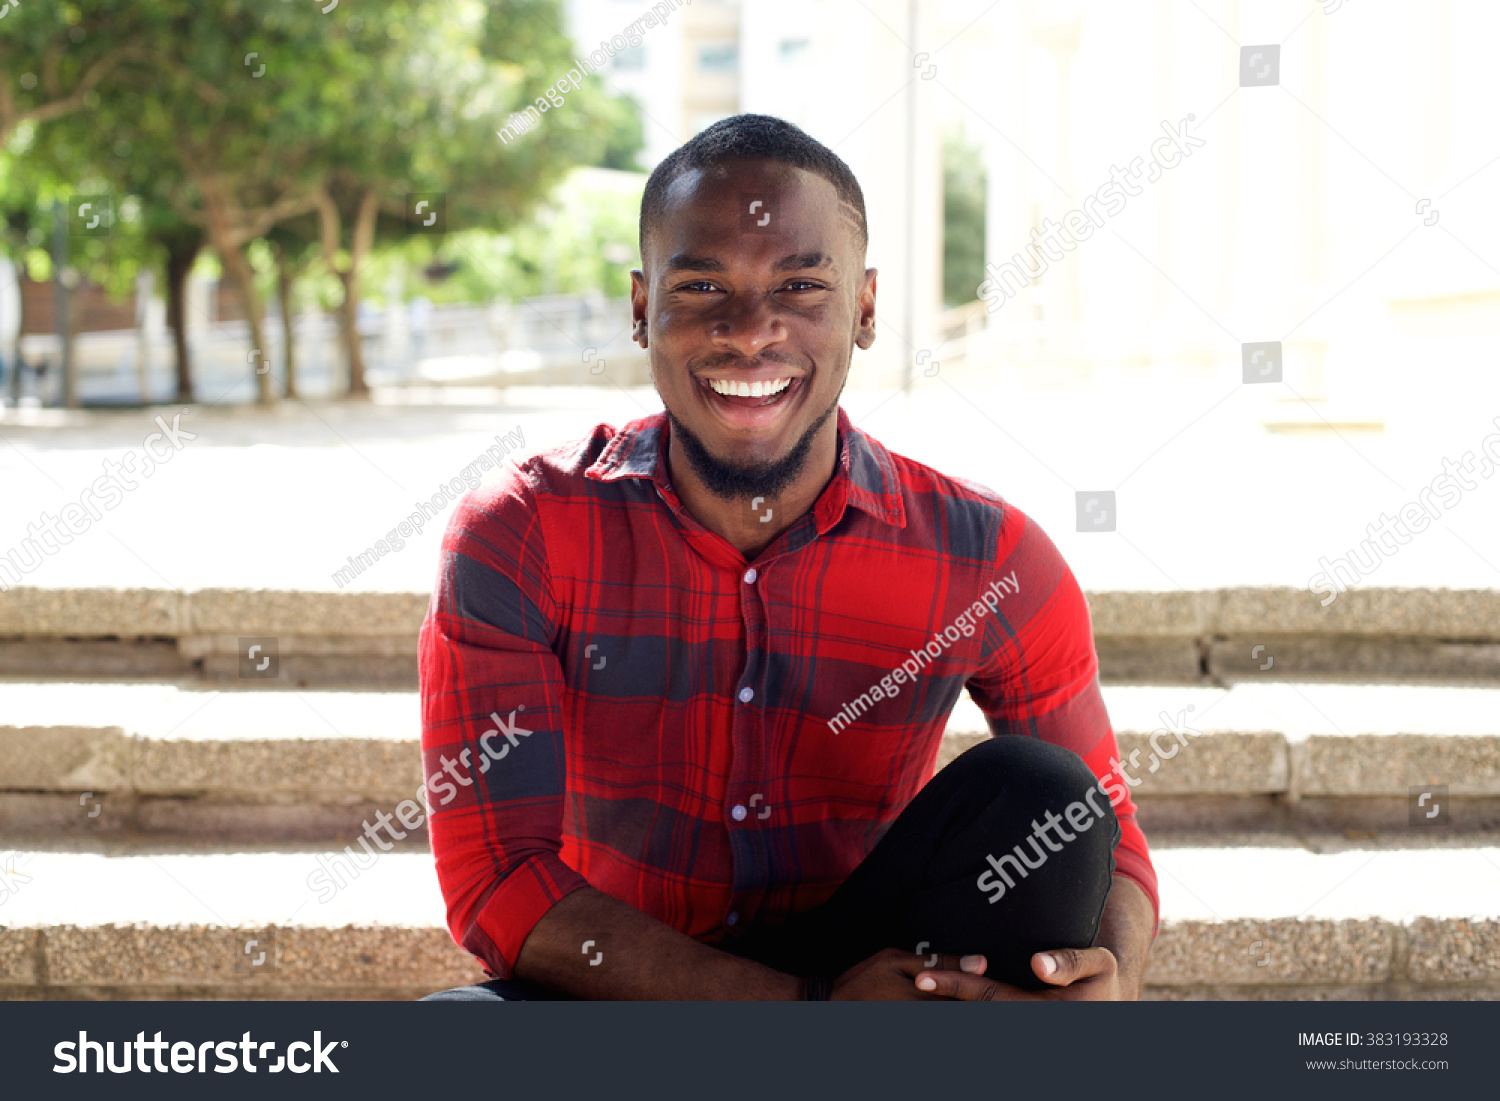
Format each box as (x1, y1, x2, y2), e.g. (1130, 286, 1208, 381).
(419, 468, 588, 978)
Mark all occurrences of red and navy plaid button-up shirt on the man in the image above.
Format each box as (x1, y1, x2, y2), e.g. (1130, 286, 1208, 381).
(420, 410, 1157, 978)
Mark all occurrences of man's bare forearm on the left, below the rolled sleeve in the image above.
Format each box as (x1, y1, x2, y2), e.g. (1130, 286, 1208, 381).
(516, 887, 803, 1001)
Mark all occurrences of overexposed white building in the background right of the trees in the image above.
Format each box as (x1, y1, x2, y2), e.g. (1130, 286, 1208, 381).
(570, 0, 1500, 419)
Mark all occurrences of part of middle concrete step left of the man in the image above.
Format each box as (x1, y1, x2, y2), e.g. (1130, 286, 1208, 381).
(0, 681, 422, 840)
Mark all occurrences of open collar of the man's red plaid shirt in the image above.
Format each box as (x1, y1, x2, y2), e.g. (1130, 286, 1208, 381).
(584, 405, 906, 534)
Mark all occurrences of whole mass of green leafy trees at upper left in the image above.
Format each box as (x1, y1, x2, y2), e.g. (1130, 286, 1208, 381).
(0, 0, 641, 402)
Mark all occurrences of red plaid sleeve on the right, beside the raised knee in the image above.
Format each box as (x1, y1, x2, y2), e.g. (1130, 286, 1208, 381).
(968, 509, 1161, 923)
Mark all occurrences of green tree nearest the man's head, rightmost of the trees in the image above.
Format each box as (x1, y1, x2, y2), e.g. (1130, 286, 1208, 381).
(304, 0, 641, 396)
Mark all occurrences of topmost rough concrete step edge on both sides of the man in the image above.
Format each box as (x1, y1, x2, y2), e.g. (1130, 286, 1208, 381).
(0, 588, 1500, 687)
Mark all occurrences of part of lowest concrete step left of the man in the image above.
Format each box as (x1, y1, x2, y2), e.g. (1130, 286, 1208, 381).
(0, 846, 483, 999)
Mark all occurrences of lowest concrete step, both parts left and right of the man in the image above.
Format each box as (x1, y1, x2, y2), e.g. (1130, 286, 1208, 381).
(0, 839, 1500, 999)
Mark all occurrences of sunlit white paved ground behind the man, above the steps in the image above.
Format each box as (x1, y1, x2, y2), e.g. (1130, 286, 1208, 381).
(0, 374, 1500, 591)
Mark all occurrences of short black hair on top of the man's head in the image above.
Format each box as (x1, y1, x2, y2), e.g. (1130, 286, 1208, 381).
(641, 114, 870, 264)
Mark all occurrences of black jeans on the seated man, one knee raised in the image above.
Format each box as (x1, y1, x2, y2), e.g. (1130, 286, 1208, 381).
(423, 735, 1121, 1002)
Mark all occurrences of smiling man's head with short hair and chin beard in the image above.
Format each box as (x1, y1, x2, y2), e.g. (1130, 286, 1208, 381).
(632, 116, 876, 498)
